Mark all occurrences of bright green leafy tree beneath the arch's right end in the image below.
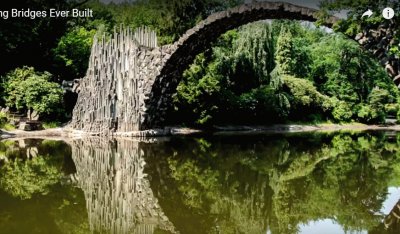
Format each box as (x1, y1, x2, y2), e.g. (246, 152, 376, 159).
(309, 34, 399, 123)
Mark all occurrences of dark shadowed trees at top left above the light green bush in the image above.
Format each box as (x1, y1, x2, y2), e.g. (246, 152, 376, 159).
(0, 0, 92, 75)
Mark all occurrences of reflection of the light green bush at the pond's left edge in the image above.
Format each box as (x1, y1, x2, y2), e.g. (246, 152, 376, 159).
(0, 139, 70, 199)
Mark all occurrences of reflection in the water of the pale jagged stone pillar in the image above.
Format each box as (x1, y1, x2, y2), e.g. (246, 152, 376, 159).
(71, 139, 177, 234)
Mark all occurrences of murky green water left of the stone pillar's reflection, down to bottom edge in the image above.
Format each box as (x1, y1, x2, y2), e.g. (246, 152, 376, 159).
(0, 139, 90, 233)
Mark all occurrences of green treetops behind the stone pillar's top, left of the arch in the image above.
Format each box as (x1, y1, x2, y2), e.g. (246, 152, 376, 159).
(100, 0, 243, 44)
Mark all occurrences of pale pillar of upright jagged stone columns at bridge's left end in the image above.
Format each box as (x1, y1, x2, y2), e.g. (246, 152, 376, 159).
(69, 28, 162, 135)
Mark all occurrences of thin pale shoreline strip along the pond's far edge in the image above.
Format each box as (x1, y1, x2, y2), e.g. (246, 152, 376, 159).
(0, 123, 400, 140)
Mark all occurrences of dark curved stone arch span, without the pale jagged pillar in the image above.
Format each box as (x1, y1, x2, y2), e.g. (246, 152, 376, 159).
(143, 2, 339, 129)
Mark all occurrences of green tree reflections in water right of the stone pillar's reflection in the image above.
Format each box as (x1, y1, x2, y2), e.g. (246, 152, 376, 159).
(145, 134, 400, 233)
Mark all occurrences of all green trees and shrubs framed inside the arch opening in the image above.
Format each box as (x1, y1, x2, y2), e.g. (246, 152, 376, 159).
(175, 21, 399, 125)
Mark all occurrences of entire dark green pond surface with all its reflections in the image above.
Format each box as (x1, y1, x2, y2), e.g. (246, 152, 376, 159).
(0, 132, 400, 234)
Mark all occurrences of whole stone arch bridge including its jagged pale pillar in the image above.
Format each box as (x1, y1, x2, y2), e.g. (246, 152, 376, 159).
(69, 2, 400, 135)
